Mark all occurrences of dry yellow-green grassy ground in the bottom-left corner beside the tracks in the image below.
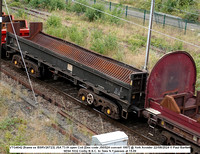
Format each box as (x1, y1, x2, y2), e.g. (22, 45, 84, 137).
(0, 82, 75, 154)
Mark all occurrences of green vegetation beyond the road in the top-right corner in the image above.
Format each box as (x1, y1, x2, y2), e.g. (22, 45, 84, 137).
(118, 0, 200, 21)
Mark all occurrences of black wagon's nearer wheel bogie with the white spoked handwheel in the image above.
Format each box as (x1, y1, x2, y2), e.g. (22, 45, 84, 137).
(78, 88, 120, 119)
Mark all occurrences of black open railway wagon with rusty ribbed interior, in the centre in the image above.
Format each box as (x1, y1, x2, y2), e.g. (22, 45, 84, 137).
(2, 23, 147, 119)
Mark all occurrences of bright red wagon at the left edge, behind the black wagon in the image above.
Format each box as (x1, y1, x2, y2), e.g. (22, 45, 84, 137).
(1, 12, 29, 44)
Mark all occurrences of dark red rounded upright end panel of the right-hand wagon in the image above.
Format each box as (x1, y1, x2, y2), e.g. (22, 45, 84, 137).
(145, 51, 196, 106)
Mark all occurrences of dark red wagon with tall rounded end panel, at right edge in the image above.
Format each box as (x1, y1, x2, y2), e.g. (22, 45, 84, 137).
(143, 51, 200, 154)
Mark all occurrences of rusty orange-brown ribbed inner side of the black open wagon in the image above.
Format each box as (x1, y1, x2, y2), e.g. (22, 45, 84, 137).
(31, 33, 139, 84)
